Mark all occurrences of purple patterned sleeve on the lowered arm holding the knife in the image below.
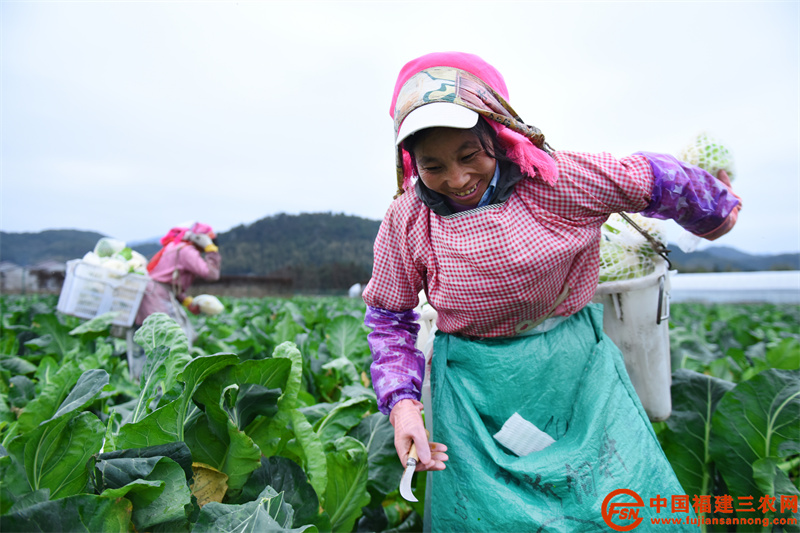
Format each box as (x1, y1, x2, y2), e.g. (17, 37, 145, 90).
(364, 306, 425, 415)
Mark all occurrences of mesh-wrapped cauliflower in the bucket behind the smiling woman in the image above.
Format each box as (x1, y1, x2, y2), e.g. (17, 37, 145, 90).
(599, 213, 666, 283)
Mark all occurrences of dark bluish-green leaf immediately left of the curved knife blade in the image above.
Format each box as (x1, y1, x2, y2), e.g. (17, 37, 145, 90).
(349, 413, 403, 496)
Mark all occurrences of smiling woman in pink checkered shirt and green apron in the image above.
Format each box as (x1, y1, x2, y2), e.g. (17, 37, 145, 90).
(364, 53, 741, 531)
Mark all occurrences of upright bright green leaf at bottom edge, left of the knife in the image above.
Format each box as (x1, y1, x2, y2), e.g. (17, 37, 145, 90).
(325, 437, 370, 532)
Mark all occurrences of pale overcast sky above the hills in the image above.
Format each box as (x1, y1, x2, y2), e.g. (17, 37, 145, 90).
(0, 0, 800, 253)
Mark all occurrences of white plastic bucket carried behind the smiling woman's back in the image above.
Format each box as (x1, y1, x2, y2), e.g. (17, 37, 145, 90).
(593, 260, 672, 422)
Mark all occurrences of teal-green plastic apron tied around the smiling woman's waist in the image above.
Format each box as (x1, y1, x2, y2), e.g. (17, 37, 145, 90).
(426, 304, 697, 532)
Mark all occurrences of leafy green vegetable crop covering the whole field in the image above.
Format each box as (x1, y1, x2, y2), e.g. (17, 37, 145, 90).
(0, 296, 800, 532)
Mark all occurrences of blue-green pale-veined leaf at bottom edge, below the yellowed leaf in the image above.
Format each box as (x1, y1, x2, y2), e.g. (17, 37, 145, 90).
(192, 487, 317, 533)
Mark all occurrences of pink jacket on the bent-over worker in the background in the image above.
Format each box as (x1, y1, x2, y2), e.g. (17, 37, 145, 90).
(136, 242, 222, 325)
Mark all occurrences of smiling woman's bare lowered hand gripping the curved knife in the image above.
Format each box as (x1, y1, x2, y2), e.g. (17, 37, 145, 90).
(389, 399, 448, 472)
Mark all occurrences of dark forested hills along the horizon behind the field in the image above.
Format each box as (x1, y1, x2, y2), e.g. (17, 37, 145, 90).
(0, 213, 800, 290)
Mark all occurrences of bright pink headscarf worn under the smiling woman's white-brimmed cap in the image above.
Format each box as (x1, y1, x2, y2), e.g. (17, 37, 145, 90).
(389, 52, 558, 189)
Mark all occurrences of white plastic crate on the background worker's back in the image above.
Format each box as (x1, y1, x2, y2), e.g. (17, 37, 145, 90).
(57, 259, 150, 327)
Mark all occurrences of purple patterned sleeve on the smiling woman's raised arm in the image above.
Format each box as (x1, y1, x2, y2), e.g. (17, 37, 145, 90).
(639, 152, 740, 236)
